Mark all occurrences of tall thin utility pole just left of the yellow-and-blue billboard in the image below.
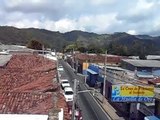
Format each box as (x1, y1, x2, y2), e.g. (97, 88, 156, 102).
(102, 50, 107, 102)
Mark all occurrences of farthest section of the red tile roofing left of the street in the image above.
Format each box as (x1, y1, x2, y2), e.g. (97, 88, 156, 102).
(6, 54, 56, 71)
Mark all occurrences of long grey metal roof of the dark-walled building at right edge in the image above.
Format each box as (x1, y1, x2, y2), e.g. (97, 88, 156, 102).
(123, 59, 160, 67)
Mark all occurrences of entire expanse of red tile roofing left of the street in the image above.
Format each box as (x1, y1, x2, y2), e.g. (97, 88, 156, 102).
(0, 54, 69, 117)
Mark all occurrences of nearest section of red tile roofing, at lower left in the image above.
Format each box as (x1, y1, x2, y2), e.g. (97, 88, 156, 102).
(0, 92, 53, 114)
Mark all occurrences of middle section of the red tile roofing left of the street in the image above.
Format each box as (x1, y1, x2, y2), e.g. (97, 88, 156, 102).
(0, 70, 55, 92)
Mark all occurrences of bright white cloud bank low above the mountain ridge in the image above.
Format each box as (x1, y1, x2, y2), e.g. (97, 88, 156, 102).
(7, 14, 117, 33)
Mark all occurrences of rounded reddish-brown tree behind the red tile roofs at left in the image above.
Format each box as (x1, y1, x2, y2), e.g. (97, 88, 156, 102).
(27, 40, 42, 50)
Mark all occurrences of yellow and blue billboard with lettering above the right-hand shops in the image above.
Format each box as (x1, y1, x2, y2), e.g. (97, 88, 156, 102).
(111, 85, 154, 102)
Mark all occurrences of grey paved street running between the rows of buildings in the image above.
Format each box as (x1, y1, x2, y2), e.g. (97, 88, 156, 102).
(60, 61, 109, 120)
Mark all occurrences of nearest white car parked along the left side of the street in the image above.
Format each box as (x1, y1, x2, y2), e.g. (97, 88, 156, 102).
(64, 87, 73, 102)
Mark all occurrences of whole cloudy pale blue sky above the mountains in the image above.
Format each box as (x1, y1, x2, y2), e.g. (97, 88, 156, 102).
(0, 0, 160, 36)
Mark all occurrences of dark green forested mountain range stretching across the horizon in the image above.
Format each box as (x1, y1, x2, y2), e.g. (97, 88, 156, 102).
(0, 26, 160, 55)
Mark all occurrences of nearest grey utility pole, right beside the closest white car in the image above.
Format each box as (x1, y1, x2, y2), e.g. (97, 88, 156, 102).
(71, 79, 77, 120)
